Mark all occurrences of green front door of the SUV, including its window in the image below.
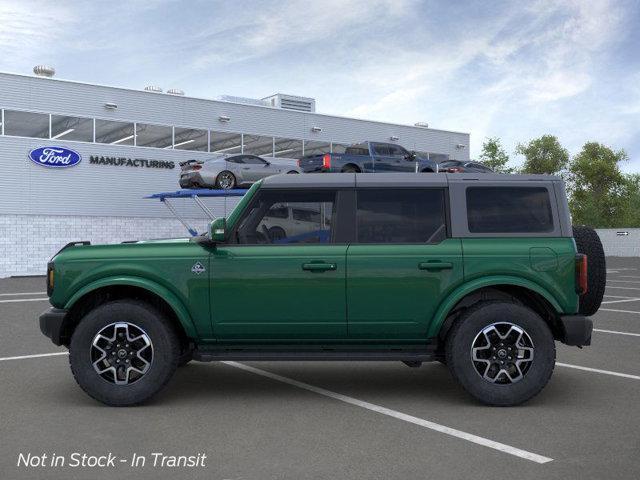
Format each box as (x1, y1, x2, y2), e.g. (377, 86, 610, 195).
(211, 189, 347, 342)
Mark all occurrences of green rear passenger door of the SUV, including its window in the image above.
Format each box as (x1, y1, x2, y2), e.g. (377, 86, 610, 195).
(347, 184, 463, 341)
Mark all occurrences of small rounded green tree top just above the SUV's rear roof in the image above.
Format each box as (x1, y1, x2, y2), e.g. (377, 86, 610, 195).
(516, 135, 569, 175)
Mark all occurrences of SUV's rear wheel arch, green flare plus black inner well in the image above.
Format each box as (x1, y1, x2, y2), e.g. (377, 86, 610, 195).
(427, 277, 562, 340)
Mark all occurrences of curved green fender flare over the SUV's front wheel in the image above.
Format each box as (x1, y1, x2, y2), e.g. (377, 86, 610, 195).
(64, 276, 198, 338)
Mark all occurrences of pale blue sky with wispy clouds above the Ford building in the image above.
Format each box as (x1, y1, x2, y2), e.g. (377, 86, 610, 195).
(0, 0, 640, 172)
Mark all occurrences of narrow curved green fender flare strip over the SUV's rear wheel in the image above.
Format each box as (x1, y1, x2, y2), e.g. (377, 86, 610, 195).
(427, 275, 562, 338)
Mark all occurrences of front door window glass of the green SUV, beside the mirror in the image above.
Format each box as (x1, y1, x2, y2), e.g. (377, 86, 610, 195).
(236, 190, 336, 245)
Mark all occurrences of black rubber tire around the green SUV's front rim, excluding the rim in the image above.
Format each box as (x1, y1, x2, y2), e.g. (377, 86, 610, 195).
(69, 300, 180, 407)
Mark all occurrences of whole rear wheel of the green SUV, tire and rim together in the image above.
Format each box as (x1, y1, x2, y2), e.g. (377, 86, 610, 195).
(445, 302, 556, 406)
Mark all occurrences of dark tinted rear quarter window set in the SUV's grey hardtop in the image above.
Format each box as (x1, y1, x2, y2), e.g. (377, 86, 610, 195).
(467, 187, 553, 233)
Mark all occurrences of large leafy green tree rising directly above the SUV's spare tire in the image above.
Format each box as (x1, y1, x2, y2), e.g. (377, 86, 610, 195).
(569, 142, 638, 228)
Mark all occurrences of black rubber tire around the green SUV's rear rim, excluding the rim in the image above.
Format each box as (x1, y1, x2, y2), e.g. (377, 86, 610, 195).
(445, 301, 556, 406)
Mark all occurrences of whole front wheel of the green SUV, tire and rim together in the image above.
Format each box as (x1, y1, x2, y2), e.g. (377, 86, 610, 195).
(69, 300, 180, 406)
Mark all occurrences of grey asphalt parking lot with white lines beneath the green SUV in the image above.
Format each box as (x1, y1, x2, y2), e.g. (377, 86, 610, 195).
(0, 258, 640, 479)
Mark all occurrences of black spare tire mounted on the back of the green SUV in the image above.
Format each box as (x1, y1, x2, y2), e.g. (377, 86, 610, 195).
(573, 226, 607, 316)
